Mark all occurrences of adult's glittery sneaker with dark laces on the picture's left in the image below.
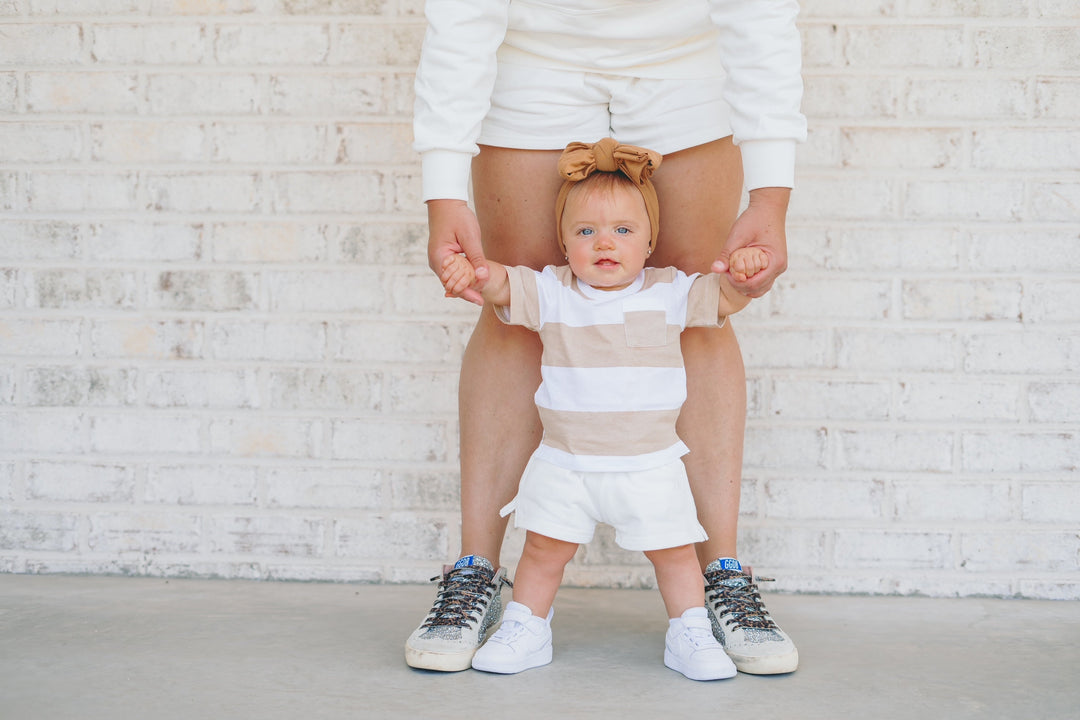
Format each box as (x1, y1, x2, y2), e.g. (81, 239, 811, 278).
(405, 555, 513, 673)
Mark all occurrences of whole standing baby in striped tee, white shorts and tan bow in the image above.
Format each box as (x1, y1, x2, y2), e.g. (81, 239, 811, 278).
(441, 138, 769, 680)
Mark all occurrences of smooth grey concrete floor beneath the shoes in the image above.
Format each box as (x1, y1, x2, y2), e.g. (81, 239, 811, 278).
(0, 574, 1080, 720)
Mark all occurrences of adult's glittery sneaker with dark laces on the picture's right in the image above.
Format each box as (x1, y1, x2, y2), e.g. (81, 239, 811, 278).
(705, 558, 799, 675)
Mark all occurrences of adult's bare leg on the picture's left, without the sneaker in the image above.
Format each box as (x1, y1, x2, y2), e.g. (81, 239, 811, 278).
(458, 146, 562, 566)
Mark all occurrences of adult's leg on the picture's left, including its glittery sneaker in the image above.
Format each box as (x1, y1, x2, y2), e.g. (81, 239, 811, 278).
(405, 147, 562, 671)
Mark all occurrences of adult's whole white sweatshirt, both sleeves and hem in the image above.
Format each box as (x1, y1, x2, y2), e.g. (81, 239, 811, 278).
(414, 0, 806, 201)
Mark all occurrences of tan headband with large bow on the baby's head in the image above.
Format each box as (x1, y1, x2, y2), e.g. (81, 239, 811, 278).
(555, 137, 661, 255)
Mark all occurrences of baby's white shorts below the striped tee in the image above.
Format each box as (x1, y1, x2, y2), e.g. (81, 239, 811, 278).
(501, 456, 707, 551)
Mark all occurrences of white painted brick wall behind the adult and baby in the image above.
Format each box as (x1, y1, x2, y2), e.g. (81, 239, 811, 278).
(0, 0, 1080, 599)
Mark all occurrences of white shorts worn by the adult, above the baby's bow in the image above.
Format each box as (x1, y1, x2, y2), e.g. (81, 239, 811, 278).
(477, 65, 731, 154)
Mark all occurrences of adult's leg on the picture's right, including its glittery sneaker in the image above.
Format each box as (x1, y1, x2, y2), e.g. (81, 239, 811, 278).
(653, 138, 799, 675)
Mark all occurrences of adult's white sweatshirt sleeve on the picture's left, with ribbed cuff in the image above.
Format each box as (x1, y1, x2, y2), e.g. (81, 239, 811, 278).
(413, 0, 510, 201)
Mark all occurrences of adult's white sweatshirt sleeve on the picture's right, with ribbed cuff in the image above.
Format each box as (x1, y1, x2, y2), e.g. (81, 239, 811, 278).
(710, 0, 807, 190)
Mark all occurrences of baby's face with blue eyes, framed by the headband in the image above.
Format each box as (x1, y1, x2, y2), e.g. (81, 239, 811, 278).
(563, 188, 652, 290)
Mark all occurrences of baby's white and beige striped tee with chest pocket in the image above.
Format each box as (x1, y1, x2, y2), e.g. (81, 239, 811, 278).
(496, 266, 724, 472)
